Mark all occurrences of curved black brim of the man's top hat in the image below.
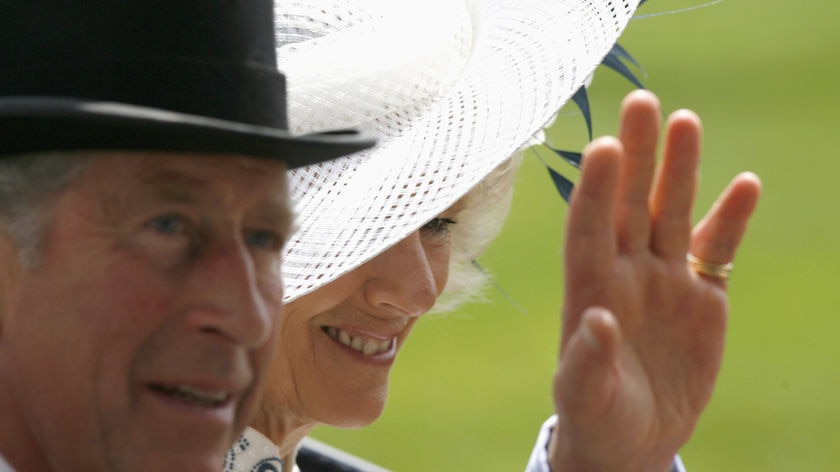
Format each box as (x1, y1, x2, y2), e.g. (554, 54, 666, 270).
(0, 97, 376, 168)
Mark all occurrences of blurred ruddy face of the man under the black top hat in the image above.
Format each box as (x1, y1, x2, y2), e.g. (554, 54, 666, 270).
(0, 154, 290, 472)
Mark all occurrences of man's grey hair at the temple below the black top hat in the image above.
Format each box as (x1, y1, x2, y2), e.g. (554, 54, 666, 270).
(0, 152, 90, 269)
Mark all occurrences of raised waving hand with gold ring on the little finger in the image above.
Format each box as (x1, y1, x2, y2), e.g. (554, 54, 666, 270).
(549, 91, 760, 472)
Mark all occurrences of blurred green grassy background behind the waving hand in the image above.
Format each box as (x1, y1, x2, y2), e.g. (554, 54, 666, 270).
(314, 0, 840, 472)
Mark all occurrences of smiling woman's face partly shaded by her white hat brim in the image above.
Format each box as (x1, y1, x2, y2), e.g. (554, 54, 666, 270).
(263, 207, 459, 428)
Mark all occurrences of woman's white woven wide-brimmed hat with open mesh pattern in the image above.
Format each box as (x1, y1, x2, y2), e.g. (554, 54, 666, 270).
(275, 0, 639, 301)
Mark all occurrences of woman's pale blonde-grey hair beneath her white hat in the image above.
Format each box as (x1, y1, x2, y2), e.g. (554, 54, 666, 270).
(432, 150, 524, 313)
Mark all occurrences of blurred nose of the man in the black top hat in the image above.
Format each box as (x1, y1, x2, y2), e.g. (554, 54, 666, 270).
(189, 239, 274, 348)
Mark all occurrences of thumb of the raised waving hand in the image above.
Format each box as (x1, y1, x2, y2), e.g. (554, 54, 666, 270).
(554, 307, 620, 422)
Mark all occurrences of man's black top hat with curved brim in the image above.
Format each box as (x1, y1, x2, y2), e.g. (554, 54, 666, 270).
(0, 0, 374, 167)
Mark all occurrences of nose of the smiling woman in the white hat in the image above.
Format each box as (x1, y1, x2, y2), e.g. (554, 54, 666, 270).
(365, 232, 439, 316)
